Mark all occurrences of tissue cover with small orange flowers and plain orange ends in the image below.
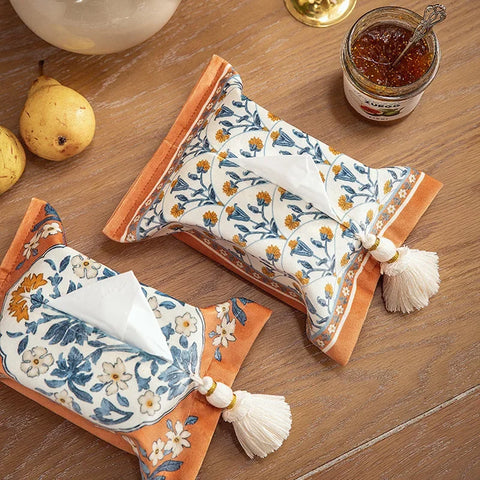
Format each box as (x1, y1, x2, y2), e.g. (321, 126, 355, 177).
(104, 56, 441, 364)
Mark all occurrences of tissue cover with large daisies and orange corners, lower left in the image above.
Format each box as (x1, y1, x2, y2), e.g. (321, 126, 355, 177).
(0, 200, 271, 480)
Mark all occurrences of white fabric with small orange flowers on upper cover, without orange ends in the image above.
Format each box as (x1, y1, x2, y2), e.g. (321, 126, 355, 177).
(129, 69, 420, 345)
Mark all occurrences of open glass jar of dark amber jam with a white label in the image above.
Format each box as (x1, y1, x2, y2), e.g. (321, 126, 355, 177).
(341, 7, 440, 122)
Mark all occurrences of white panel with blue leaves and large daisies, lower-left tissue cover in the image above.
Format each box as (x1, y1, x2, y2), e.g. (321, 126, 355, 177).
(0, 245, 205, 432)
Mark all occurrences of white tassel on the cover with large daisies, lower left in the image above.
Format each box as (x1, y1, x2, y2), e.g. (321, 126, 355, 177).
(196, 377, 292, 458)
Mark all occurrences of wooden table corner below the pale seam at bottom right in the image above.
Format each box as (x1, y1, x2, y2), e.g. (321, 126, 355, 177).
(299, 387, 480, 480)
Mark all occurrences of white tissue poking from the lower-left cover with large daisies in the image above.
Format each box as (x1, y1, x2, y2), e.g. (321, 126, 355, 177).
(49, 272, 173, 361)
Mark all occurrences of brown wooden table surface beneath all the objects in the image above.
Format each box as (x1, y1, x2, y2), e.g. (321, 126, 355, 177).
(0, 0, 480, 480)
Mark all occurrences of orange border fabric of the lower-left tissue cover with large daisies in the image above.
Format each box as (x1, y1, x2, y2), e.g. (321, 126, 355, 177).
(0, 199, 272, 480)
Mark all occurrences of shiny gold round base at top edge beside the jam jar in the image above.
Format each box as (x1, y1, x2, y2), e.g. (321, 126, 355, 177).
(284, 0, 357, 27)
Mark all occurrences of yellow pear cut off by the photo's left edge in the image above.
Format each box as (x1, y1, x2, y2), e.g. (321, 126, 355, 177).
(0, 126, 25, 195)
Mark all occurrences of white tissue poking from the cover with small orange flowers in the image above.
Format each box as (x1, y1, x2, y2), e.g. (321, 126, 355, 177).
(232, 155, 338, 221)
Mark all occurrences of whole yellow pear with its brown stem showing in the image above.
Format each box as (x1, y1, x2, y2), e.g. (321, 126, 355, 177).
(20, 75, 95, 161)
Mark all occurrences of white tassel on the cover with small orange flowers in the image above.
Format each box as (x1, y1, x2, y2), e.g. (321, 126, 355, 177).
(358, 234, 440, 313)
